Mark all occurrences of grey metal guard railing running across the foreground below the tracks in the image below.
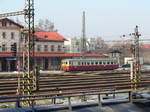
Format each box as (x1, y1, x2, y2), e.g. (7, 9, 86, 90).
(0, 91, 132, 111)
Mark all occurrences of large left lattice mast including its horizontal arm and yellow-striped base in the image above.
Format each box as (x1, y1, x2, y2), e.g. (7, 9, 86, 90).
(0, 0, 39, 106)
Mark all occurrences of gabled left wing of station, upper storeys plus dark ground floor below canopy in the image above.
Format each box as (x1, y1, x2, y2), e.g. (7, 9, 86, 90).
(0, 18, 23, 71)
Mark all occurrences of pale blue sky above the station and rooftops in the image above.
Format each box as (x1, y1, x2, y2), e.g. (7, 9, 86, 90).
(0, 0, 150, 40)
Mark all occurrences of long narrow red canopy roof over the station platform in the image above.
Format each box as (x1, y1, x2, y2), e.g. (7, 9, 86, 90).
(0, 53, 108, 57)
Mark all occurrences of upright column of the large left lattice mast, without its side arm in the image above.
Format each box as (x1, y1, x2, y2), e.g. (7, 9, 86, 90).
(21, 0, 36, 106)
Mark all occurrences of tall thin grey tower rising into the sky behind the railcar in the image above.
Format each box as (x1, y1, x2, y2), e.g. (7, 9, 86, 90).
(81, 11, 87, 55)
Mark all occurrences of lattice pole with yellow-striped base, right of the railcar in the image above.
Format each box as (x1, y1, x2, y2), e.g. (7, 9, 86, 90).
(130, 26, 141, 91)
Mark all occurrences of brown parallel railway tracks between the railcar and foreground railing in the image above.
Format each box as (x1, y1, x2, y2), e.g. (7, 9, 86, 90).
(0, 72, 150, 96)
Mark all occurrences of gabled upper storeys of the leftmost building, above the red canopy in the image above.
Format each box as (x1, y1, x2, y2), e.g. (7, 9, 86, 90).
(0, 18, 23, 52)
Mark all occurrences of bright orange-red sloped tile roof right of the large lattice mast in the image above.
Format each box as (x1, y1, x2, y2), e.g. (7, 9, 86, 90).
(34, 32, 66, 41)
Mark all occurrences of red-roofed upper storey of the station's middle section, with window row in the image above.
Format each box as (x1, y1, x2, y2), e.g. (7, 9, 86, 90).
(35, 32, 66, 53)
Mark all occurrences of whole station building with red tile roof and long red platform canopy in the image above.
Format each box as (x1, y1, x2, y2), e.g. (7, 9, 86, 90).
(0, 18, 107, 71)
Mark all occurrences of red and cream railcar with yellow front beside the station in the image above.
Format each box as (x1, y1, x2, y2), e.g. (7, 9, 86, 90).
(61, 58, 119, 71)
